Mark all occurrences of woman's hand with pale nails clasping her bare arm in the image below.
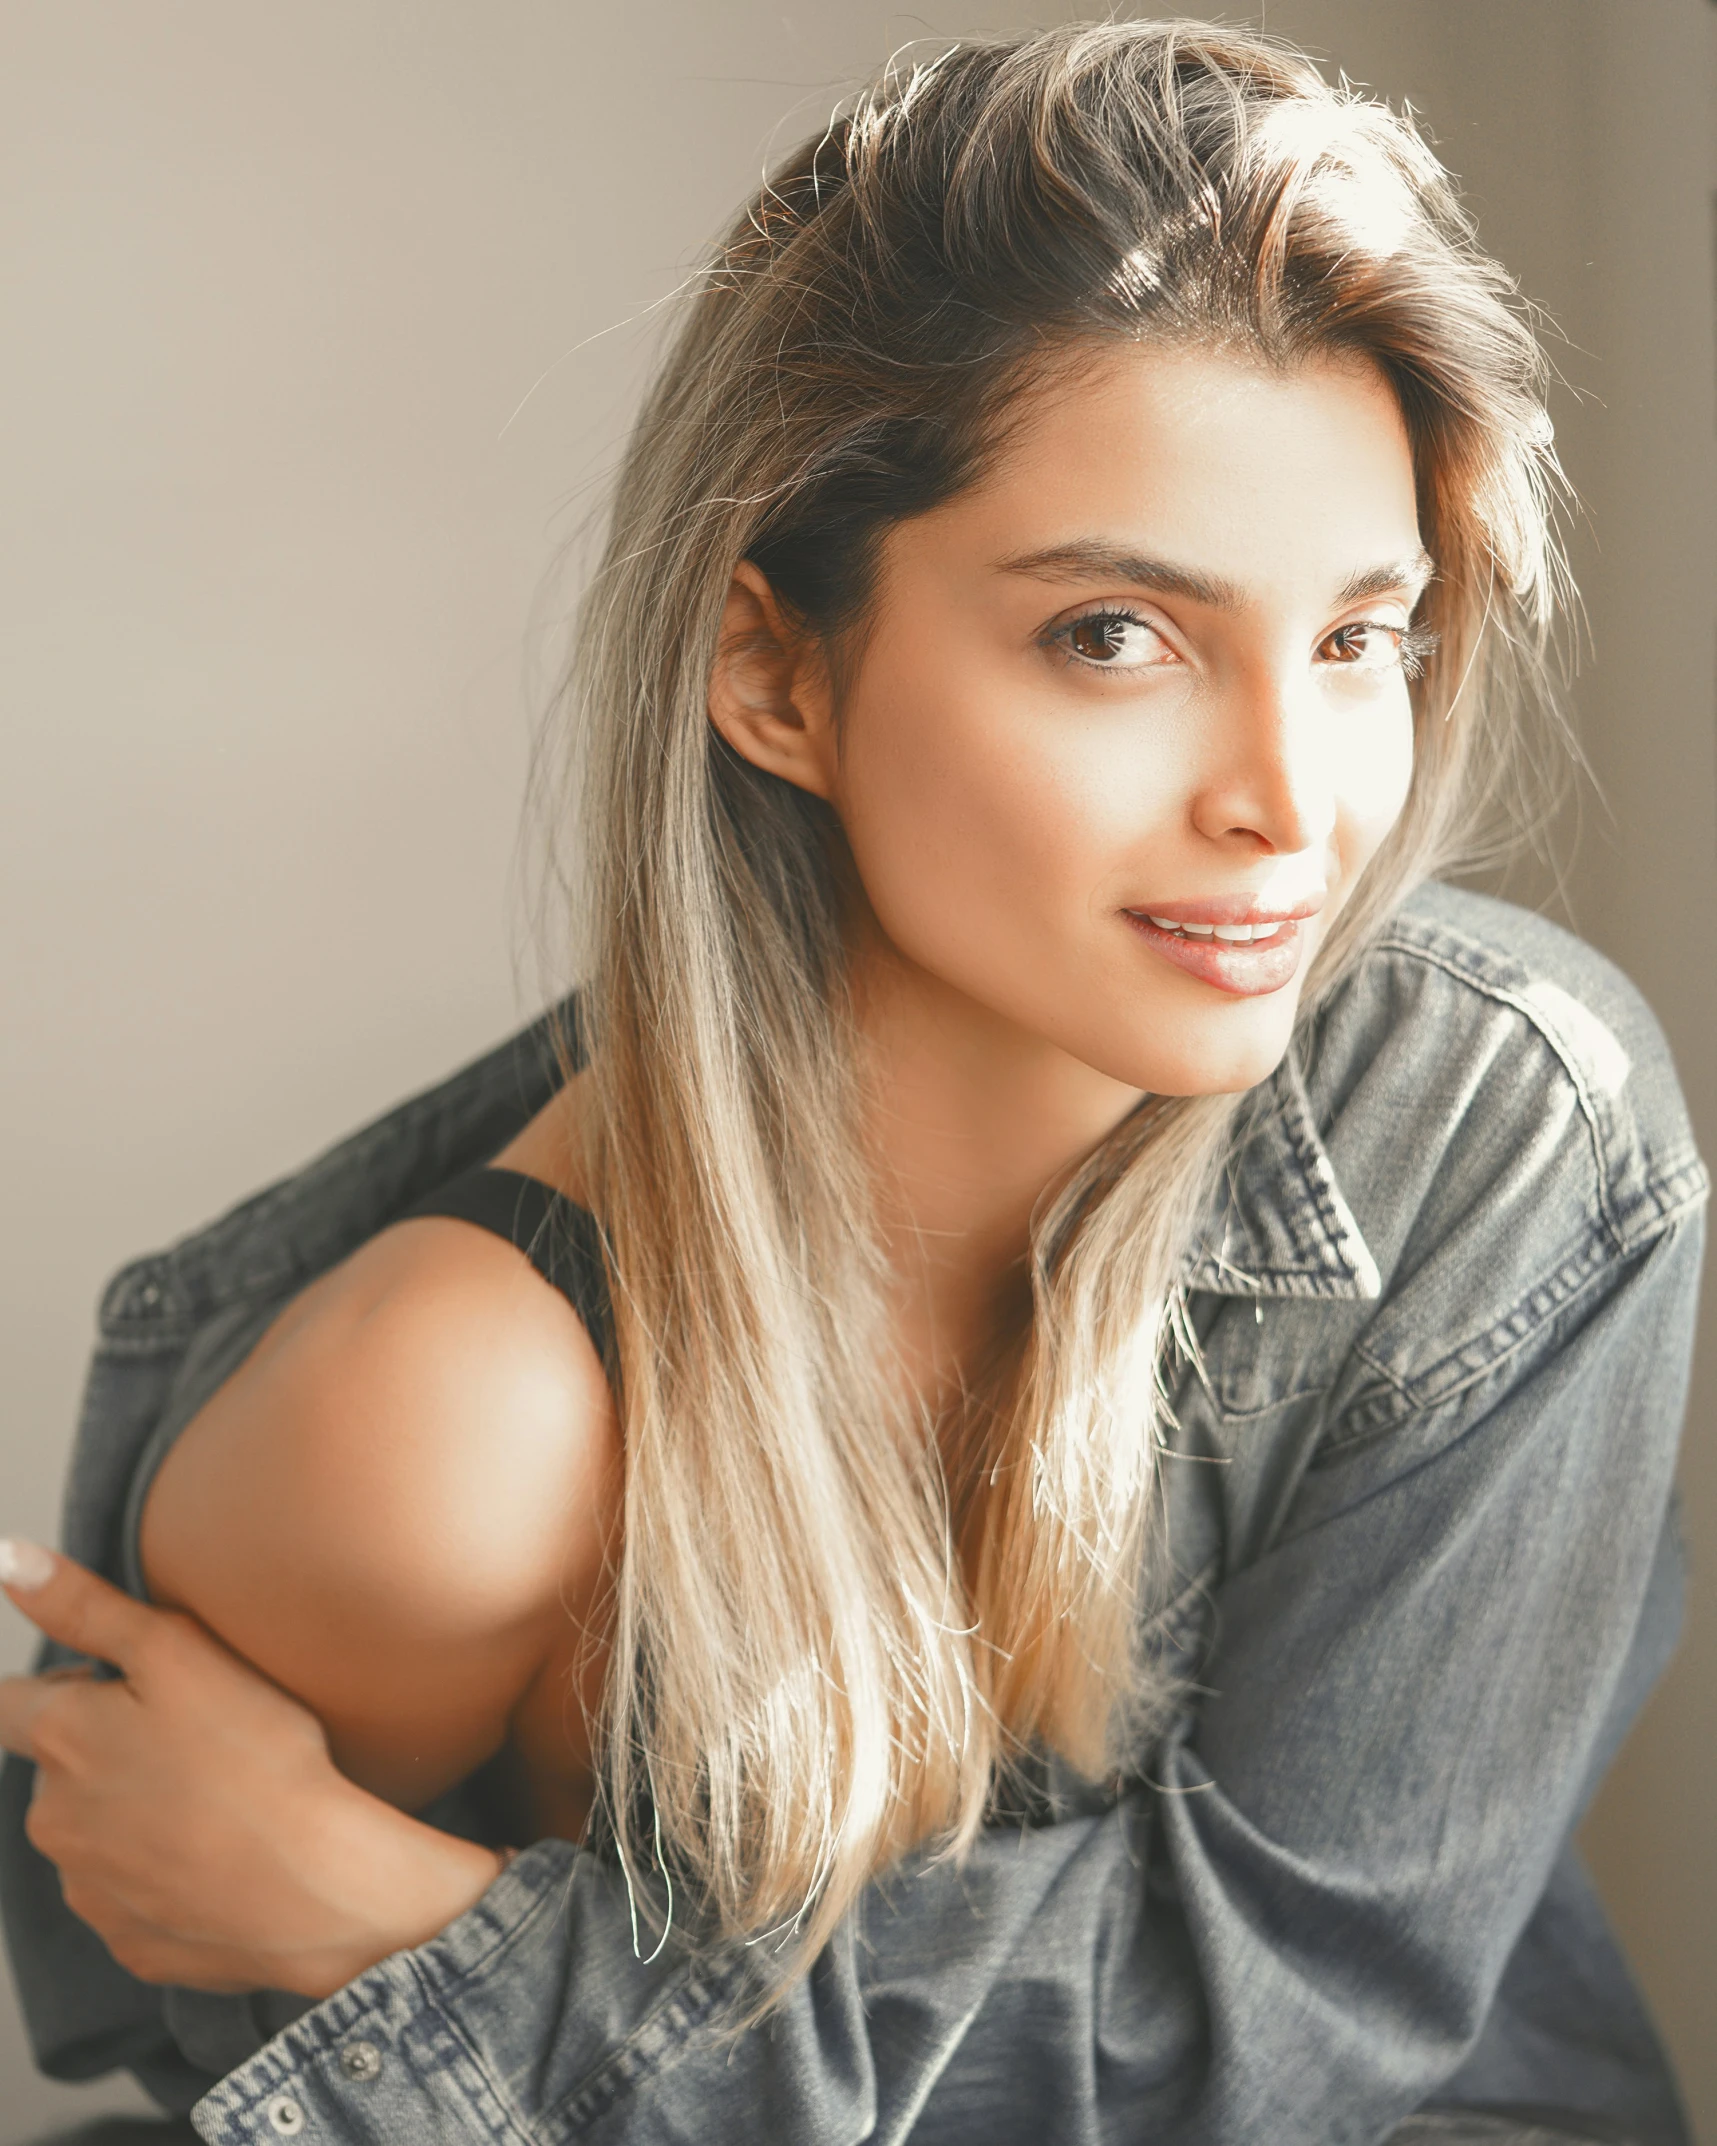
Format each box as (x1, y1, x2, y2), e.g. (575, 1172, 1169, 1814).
(0, 1543, 510, 1998)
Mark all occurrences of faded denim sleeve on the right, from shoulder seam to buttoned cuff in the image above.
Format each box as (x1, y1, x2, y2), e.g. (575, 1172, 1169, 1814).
(195, 1217, 1702, 2146)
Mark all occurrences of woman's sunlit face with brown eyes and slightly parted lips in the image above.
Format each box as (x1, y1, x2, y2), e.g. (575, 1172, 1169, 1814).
(742, 346, 1429, 1094)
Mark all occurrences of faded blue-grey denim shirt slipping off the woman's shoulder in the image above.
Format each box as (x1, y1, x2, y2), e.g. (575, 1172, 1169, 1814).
(0, 886, 1706, 2146)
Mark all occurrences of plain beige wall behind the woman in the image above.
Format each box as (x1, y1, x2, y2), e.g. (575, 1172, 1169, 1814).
(0, 0, 1717, 2146)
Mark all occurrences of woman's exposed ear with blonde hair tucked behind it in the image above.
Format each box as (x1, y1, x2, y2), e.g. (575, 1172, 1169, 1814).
(710, 558, 835, 798)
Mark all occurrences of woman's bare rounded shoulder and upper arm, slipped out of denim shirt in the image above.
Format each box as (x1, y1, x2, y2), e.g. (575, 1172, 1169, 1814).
(142, 1217, 620, 1831)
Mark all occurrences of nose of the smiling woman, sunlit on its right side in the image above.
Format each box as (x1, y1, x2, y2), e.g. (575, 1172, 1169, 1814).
(1193, 674, 1339, 856)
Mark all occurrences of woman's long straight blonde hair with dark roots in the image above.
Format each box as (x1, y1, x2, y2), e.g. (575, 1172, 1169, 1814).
(549, 21, 1558, 1961)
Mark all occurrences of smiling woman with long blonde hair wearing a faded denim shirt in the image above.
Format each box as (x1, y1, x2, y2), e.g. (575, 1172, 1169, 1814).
(6, 24, 1704, 2142)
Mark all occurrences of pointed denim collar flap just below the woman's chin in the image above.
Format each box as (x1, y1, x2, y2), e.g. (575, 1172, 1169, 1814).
(1185, 1049, 1382, 1298)
